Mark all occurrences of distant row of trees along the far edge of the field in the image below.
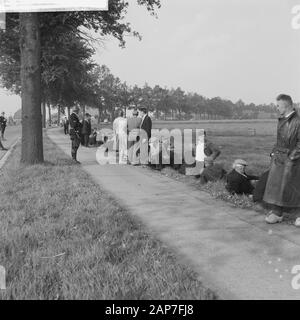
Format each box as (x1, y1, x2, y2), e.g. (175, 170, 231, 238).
(39, 65, 276, 122)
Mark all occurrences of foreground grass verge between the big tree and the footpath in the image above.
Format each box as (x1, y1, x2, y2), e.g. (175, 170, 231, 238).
(0, 139, 215, 299)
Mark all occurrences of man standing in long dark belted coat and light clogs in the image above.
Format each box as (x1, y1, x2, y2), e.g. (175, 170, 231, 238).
(263, 94, 300, 224)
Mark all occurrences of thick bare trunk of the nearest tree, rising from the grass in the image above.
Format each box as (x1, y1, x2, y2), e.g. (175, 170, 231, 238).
(20, 13, 44, 164)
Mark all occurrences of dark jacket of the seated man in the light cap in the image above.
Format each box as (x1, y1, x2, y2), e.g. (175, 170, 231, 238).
(226, 169, 258, 194)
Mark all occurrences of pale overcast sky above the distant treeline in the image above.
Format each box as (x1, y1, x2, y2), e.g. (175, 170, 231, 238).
(0, 0, 300, 112)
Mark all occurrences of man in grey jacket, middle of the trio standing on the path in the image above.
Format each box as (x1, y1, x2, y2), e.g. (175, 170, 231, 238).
(127, 109, 142, 165)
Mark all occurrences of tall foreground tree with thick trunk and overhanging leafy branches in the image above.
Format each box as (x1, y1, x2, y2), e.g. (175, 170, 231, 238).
(0, 0, 160, 164)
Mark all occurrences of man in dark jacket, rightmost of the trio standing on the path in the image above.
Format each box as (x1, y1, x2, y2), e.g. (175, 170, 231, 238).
(139, 107, 152, 164)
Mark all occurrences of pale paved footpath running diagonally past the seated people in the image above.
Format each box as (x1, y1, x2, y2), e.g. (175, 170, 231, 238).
(48, 129, 300, 299)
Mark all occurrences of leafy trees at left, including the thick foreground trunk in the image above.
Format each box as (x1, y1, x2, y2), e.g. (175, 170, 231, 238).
(0, 0, 160, 164)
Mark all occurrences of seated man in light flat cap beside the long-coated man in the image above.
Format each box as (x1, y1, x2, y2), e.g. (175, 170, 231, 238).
(226, 159, 259, 195)
